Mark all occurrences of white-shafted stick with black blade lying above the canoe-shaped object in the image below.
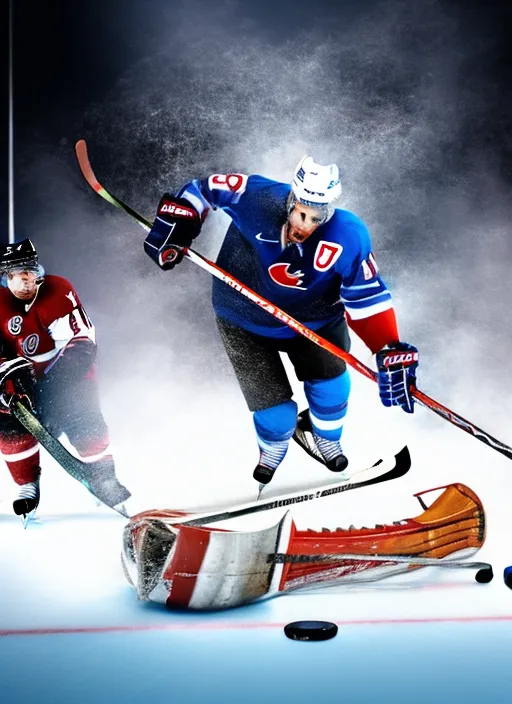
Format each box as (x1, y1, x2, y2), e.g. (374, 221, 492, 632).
(172, 445, 411, 526)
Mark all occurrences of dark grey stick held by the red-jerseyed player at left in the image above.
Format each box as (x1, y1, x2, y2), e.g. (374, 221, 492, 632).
(13, 401, 128, 518)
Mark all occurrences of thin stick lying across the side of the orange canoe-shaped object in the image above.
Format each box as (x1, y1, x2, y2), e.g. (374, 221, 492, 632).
(267, 553, 494, 583)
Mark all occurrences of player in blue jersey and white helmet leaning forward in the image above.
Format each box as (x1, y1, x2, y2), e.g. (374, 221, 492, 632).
(144, 156, 418, 484)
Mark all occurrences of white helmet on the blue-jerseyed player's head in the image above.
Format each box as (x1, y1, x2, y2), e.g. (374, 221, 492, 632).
(292, 156, 341, 207)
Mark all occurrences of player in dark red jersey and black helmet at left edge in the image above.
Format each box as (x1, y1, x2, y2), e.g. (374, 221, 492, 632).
(0, 239, 130, 516)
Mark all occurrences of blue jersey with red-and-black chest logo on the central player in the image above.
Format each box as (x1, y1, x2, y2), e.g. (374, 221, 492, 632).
(178, 174, 392, 338)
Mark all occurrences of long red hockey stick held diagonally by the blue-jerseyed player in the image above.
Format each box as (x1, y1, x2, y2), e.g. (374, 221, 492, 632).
(75, 139, 512, 459)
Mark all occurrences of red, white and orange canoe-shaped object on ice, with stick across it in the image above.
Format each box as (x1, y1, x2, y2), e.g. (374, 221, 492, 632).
(121, 483, 493, 609)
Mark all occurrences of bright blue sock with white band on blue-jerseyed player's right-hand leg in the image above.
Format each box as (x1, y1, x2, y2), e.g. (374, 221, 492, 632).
(304, 371, 350, 440)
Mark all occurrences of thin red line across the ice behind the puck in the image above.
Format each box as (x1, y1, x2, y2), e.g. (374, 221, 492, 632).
(0, 614, 512, 637)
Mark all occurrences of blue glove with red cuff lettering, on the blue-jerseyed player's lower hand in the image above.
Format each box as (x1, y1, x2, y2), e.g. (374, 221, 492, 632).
(376, 342, 419, 413)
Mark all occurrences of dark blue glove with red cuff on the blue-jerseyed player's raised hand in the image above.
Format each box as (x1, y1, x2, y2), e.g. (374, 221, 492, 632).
(144, 193, 202, 270)
